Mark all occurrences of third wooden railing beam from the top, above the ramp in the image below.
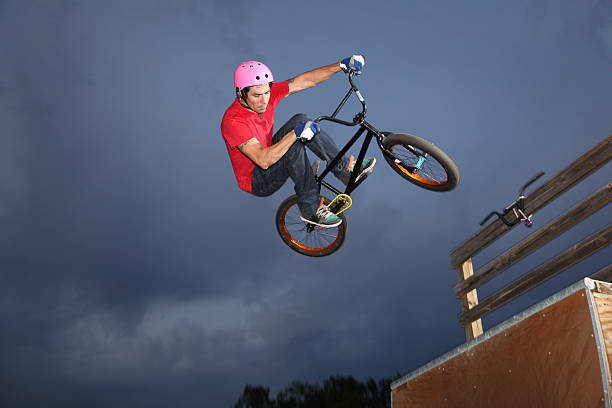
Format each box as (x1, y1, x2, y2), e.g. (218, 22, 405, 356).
(459, 224, 612, 326)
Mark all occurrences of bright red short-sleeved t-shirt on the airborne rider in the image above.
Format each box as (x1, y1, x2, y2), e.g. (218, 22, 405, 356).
(221, 81, 289, 193)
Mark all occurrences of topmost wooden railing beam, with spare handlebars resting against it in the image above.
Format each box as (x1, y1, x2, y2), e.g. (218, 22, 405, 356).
(450, 135, 612, 269)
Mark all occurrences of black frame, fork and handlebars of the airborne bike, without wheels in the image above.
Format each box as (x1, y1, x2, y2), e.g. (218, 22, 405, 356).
(315, 71, 397, 195)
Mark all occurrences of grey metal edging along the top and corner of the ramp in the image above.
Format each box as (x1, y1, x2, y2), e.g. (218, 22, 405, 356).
(391, 278, 596, 390)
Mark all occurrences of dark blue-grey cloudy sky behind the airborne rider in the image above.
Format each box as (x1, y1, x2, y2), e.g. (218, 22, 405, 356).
(0, 0, 612, 407)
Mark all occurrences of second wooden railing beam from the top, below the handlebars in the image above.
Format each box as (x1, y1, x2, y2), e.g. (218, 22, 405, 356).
(454, 182, 612, 297)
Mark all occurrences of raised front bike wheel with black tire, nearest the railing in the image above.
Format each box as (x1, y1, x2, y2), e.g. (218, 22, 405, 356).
(383, 133, 459, 191)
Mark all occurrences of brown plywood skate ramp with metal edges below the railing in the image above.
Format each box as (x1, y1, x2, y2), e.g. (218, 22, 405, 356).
(391, 278, 612, 408)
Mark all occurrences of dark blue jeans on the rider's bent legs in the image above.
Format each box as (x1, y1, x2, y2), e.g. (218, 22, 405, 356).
(251, 113, 348, 217)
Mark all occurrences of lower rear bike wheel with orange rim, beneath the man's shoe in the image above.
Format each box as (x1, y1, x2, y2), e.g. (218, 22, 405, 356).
(276, 195, 347, 257)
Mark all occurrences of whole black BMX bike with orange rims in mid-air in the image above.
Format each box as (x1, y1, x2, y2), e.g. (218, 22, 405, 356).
(276, 71, 459, 257)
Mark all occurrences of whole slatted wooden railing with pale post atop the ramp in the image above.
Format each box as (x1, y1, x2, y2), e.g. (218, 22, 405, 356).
(450, 135, 612, 341)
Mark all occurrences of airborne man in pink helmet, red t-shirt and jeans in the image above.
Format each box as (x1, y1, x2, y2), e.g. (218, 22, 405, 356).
(221, 55, 376, 228)
